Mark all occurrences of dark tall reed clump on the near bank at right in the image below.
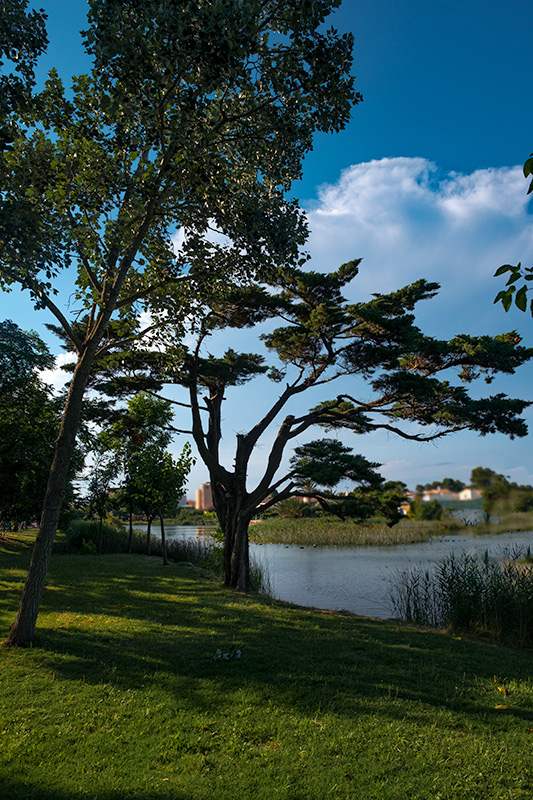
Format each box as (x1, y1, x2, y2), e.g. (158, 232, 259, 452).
(390, 552, 533, 645)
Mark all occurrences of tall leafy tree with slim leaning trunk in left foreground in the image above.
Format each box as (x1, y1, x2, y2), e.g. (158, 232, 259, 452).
(0, 0, 360, 645)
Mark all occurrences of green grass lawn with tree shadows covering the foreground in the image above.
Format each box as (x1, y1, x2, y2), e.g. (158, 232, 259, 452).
(0, 542, 533, 800)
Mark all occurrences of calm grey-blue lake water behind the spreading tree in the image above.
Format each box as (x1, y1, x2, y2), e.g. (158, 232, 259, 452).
(143, 526, 533, 619)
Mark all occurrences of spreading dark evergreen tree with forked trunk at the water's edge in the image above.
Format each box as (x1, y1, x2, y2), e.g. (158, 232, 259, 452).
(152, 261, 533, 589)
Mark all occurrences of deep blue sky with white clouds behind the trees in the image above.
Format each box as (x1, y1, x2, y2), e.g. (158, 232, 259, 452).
(4, 0, 533, 496)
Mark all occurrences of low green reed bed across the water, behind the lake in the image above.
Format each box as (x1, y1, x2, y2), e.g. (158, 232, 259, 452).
(250, 517, 462, 546)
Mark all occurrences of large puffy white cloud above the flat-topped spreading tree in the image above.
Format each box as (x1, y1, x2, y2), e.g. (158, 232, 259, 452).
(308, 158, 533, 332)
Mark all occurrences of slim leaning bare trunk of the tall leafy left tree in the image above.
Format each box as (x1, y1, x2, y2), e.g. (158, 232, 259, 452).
(6, 354, 96, 647)
